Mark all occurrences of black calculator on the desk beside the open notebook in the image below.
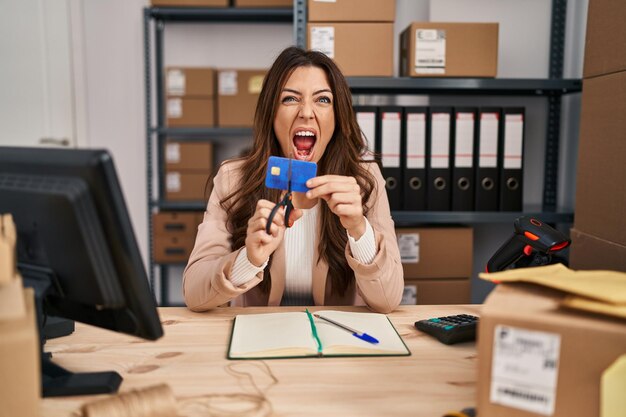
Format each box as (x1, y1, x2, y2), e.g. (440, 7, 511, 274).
(415, 314, 478, 345)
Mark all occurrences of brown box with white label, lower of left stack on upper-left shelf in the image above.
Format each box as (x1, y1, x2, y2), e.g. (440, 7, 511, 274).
(165, 97, 215, 127)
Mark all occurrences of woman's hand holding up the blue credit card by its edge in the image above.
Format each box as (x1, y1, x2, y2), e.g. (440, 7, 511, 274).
(306, 175, 365, 240)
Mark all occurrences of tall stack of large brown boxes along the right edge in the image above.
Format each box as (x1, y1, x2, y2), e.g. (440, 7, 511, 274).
(570, 0, 626, 271)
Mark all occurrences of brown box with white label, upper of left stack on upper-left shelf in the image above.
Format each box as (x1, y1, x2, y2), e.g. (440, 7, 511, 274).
(165, 67, 215, 98)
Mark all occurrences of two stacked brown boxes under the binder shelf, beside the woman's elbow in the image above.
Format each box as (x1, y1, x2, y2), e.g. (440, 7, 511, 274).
(396, 227, 473, 304)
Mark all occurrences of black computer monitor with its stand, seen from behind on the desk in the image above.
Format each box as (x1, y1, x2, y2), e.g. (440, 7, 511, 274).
(0, 147, 163, 396)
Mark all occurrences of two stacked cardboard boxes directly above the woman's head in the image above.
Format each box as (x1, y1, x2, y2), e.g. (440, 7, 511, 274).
(307, 0, 396, 77)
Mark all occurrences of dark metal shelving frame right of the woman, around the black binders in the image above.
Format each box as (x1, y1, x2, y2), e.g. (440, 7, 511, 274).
(294, 0, 582, 216)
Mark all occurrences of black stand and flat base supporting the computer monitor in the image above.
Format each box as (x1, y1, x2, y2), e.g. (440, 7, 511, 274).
(20, 265, 122, 398)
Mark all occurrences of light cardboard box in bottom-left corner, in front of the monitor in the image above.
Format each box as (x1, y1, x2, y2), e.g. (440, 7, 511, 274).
(0, 286, 41, 417)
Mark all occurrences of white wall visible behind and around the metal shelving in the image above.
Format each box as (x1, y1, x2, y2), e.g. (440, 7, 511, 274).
(73, 0, 587, 301)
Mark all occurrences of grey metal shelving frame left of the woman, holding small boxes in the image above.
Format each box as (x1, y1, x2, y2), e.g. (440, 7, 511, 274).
(143, 7, 294, 305)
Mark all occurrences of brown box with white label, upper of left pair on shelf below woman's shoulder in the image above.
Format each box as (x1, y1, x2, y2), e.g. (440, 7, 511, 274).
(165, 139, 213, 172)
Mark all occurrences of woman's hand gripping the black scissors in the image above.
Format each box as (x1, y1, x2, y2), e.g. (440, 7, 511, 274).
(246, 200, 302, 266)
